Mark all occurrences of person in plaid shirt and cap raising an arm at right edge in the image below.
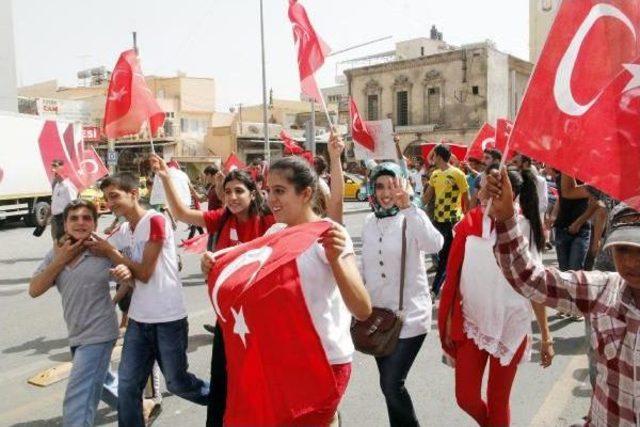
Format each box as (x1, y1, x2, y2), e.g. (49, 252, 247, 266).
(488, 170, 640, 426)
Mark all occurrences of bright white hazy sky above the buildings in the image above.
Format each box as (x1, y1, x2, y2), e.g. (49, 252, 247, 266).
(13, 0, 529, 111)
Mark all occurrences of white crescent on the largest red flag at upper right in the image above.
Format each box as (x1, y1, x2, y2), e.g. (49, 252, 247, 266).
(553, 3, 636, 116)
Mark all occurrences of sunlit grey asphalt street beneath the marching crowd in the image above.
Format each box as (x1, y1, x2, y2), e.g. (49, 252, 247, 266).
(0, 203, 591, 426)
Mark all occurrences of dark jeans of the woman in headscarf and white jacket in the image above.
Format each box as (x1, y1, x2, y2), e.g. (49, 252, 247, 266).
(376, 334, 427, 427)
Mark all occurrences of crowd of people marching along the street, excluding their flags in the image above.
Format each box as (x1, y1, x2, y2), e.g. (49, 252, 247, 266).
(29, 136, 640, 426)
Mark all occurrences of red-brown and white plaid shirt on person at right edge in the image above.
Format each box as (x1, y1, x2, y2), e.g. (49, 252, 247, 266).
(495, 218, 640, 426)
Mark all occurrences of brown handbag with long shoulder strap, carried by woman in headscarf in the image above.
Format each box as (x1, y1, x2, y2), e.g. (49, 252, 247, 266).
(351, 218, 407, 357)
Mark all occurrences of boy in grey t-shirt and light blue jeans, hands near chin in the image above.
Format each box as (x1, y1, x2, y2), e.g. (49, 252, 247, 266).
(29, 200, 131, 426)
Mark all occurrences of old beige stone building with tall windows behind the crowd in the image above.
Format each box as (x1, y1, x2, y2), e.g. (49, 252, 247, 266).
(345, 36, 533, 154)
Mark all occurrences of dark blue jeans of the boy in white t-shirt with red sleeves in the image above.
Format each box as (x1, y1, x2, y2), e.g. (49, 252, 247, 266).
(118, 317, 209, 427)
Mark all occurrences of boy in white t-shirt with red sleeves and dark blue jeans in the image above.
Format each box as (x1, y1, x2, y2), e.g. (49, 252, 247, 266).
(85, 173, 209, 426)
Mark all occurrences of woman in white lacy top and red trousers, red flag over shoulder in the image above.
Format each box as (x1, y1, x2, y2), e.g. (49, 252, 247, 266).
(438, 165, 554, 426)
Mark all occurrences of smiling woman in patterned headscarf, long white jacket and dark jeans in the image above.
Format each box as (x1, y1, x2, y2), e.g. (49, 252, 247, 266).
(362, 162, 444, 426)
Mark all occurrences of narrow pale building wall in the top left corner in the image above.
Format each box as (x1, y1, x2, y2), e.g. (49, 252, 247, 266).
(0, 0, 18, 113)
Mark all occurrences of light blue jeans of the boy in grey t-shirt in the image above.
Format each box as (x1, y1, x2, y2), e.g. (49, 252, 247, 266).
(62, 340, 118, 427)
